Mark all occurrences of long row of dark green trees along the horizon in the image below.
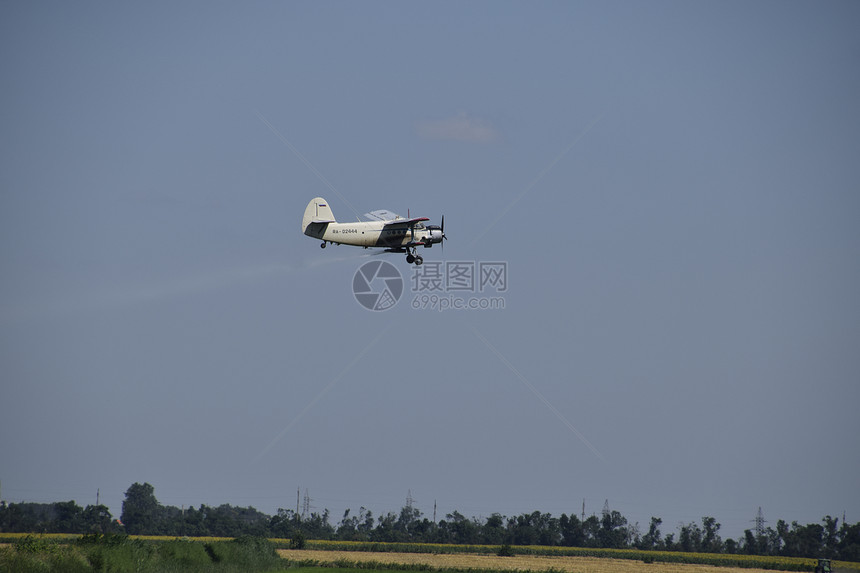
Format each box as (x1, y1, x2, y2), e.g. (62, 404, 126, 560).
(0, 483, 860, 561)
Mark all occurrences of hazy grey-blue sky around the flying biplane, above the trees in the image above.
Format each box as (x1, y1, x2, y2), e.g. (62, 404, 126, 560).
(0, 1, 860, 537)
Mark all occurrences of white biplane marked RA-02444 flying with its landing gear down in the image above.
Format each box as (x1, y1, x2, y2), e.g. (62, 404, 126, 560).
(302, 197, 447, 265)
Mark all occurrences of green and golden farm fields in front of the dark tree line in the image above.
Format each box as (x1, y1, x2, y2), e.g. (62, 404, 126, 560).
(5, 534, 860, 573)
